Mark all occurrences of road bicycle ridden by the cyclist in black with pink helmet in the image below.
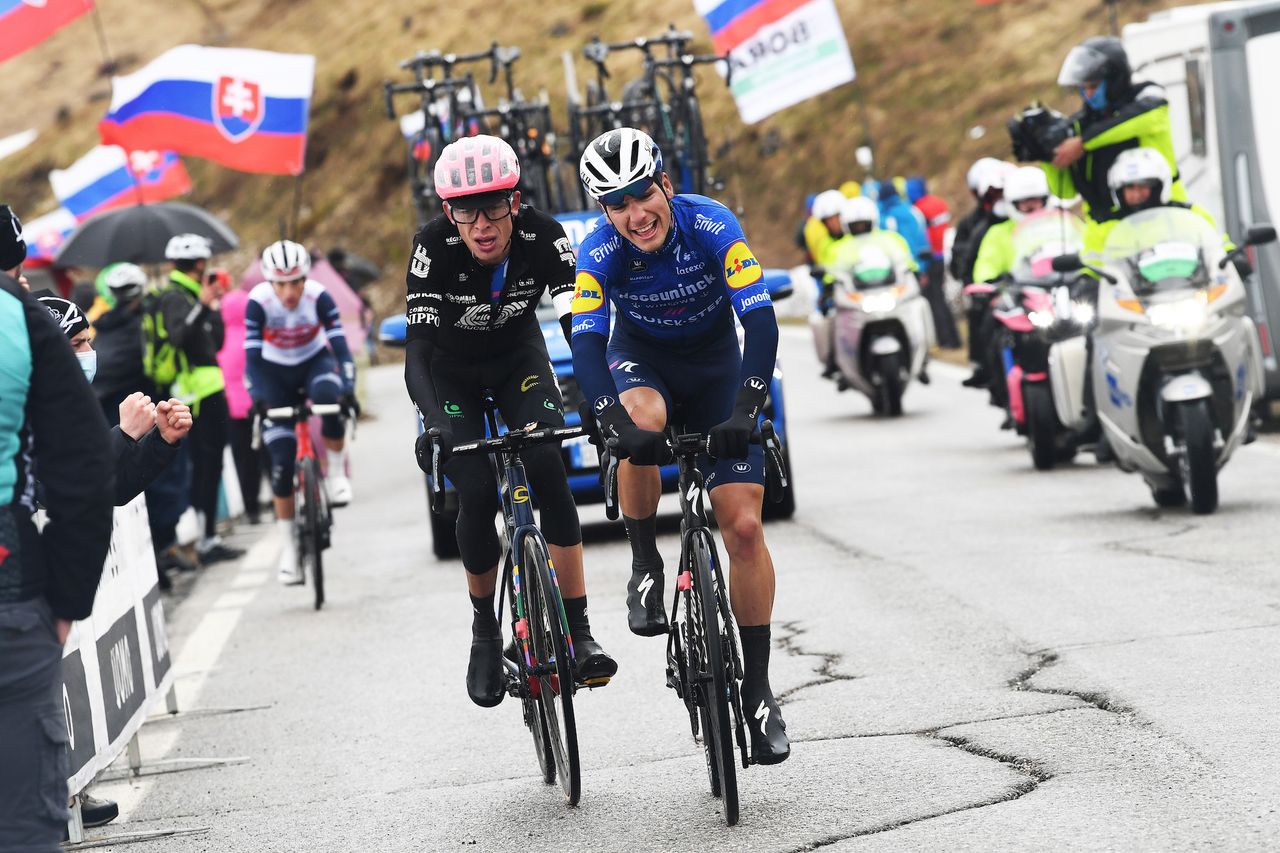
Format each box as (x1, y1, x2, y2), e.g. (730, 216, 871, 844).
(428, 398, 593, 806)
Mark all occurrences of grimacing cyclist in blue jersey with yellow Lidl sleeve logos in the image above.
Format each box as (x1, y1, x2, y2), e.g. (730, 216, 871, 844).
(572, 128, 790, 763)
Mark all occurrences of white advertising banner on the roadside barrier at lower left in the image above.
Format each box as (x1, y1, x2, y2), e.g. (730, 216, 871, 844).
(63, 496, 173, 793)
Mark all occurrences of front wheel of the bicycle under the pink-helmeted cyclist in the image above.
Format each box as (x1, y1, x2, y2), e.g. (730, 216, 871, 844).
(521, 533, 582, 806)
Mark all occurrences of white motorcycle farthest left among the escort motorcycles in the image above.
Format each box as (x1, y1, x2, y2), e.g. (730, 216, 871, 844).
(810, 232, 934, 416)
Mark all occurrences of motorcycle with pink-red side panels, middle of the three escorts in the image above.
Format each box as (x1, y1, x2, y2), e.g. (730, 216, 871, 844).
(993, 207, 1094, 470)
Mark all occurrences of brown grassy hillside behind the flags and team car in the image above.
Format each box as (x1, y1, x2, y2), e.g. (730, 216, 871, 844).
(0, 0, 1176, 312)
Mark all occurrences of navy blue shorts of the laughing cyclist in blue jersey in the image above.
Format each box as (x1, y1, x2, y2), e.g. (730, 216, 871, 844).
(605, 318, 764, 491)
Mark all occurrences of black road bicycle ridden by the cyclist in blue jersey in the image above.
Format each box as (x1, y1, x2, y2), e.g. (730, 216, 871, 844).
(600, 420, 787, 826)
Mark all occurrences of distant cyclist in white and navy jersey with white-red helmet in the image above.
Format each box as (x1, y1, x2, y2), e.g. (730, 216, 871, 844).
(244, 240, 356, 584)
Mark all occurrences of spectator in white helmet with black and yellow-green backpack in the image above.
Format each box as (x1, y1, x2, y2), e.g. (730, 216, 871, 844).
(146, 234, 244, 564)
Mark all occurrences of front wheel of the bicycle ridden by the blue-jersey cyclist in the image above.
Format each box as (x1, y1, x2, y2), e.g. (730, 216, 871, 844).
(689, 530, 739, 826)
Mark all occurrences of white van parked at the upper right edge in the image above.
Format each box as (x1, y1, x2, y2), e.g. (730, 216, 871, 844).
(1123, 0, 1280, 398)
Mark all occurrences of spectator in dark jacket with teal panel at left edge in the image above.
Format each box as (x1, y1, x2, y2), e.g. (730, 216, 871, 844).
(0, 205, 114, 853)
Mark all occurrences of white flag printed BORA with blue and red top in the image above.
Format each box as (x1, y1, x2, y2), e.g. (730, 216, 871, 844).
(694, 0, 855, 124)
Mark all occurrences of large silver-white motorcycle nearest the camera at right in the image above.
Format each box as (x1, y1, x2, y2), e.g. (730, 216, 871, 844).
(1053, 206, 1276, 514)
